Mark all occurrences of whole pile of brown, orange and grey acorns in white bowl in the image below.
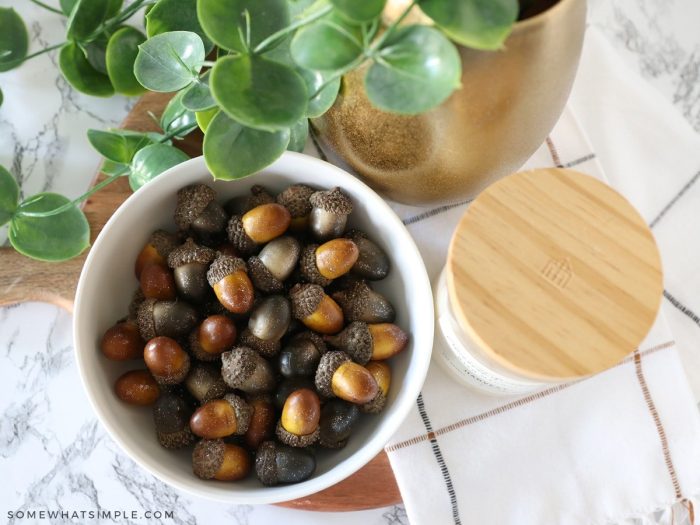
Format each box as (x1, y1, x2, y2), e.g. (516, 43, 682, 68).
(101, 184, 408, 485)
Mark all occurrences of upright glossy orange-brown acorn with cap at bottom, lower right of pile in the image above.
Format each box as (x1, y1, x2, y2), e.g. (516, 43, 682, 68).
(275, 388, 321, 447)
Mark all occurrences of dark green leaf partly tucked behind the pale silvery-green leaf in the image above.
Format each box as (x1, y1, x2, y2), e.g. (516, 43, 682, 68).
(106, 27, 146, 96)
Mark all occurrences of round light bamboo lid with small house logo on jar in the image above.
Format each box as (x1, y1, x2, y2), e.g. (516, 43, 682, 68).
(446, 168, 663, 381)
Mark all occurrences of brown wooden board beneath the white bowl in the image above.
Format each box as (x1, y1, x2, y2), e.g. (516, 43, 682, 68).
(0, 93, 401, 511)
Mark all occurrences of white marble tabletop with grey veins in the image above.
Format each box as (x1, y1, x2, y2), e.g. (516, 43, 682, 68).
(0, 0, 700, 525)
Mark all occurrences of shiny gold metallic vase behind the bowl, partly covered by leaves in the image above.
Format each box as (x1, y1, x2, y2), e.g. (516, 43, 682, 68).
(313, 0, 586, 204)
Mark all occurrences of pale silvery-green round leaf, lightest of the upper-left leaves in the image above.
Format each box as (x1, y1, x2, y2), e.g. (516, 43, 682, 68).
(134, 31, 205, 92)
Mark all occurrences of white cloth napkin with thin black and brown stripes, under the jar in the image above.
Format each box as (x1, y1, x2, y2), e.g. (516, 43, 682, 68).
(374, 29, 700, 525)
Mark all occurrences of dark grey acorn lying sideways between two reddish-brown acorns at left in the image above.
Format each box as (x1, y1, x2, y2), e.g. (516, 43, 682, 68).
(137, 299, 199, 341)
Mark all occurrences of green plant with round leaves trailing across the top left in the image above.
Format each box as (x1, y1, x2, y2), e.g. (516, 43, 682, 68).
(0, 0, 518, 260)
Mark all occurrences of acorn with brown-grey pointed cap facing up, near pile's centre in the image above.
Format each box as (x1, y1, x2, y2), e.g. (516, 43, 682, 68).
(221, 346, 275, 394)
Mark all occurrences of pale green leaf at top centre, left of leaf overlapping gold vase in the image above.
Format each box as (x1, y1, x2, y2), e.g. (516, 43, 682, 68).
(291, 13, 363, 71)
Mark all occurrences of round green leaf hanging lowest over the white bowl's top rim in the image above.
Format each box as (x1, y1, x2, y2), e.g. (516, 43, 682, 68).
(204, 111, 289, 180)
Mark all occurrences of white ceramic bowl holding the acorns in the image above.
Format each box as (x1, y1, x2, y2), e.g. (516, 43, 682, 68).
(73, 153, 433, 504)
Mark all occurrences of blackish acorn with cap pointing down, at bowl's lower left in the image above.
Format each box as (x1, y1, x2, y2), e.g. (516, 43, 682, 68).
(153, 392, 196, 448)
